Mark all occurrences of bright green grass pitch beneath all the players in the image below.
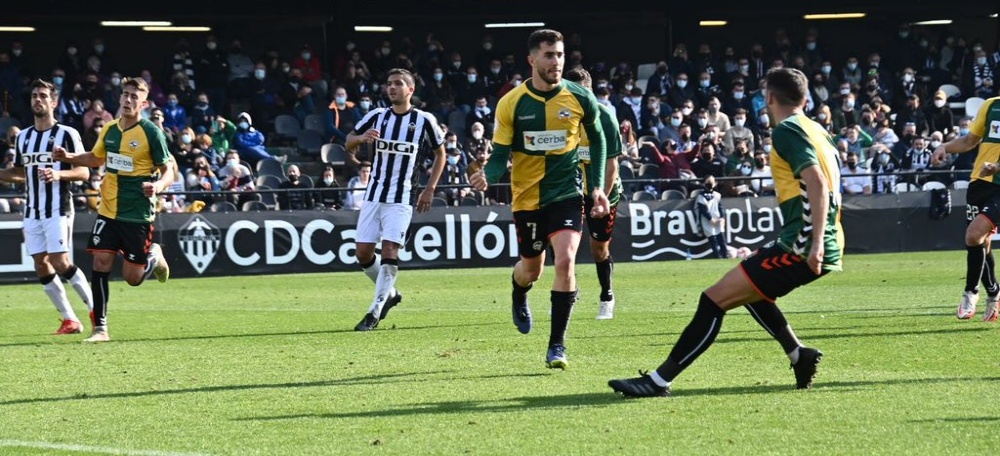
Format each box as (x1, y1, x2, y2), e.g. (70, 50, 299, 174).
(0, 251, 1000, 455)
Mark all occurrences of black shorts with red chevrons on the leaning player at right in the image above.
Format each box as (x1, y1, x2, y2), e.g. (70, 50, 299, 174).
(740, 243, 830, 302)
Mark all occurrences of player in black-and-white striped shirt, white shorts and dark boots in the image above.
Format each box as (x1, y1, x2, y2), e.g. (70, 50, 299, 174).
(346, 68, 445, 331)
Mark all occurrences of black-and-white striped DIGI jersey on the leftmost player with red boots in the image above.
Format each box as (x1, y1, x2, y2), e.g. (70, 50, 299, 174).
(14, 123, 83, 220)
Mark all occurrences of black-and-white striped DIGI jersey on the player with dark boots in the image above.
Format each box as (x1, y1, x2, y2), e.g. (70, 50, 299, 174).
(353, 108, 444, 204)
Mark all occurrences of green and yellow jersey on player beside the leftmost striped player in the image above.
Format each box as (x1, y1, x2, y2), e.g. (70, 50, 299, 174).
(93, 119, 170, 223)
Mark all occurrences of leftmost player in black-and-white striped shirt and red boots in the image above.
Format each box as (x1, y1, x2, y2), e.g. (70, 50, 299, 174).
(0, 80, 94, 334)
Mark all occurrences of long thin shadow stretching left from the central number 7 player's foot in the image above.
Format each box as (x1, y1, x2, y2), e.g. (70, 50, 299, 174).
(0, 370, 551, 407)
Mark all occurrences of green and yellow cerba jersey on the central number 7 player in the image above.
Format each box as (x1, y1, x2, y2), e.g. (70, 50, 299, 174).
(486, 80, 607, 211)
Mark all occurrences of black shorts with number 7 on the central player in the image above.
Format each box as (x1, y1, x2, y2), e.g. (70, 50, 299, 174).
(514, 197, 583, 258)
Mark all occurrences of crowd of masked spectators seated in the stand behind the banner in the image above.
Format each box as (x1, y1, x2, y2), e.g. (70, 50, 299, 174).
(0, 25, 1000, 211)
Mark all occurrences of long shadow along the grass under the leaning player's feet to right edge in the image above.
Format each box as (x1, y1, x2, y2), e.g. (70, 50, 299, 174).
(234, 377, 1000, 421)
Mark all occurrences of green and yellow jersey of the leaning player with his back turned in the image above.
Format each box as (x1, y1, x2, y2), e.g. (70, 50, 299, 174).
(771, 114, 844, 270)
